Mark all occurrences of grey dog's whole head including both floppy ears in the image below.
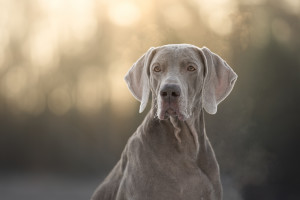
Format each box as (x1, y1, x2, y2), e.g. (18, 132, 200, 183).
(125, 44, 237, 121)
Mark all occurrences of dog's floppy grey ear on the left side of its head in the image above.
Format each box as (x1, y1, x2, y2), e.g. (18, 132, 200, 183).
(125, 47, 155, 113)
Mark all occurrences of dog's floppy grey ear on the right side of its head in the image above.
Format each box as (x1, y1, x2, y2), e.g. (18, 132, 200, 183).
(200, 47, 237, 114)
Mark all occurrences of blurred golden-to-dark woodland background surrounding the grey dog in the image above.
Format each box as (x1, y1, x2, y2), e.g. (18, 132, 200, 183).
(0, 0, 300, 200)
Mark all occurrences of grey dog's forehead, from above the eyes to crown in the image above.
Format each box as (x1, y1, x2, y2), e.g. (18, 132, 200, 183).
(153, 45, 200, 62)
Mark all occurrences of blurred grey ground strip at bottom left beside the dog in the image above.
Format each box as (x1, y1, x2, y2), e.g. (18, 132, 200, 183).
(0, 174, 99, 200)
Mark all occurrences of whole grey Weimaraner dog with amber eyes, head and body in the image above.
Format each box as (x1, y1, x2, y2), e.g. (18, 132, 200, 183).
(92, 44, 237, 200)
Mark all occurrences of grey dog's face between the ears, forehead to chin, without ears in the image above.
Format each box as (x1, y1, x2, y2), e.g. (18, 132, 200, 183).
(149, 47, 205, 120)
